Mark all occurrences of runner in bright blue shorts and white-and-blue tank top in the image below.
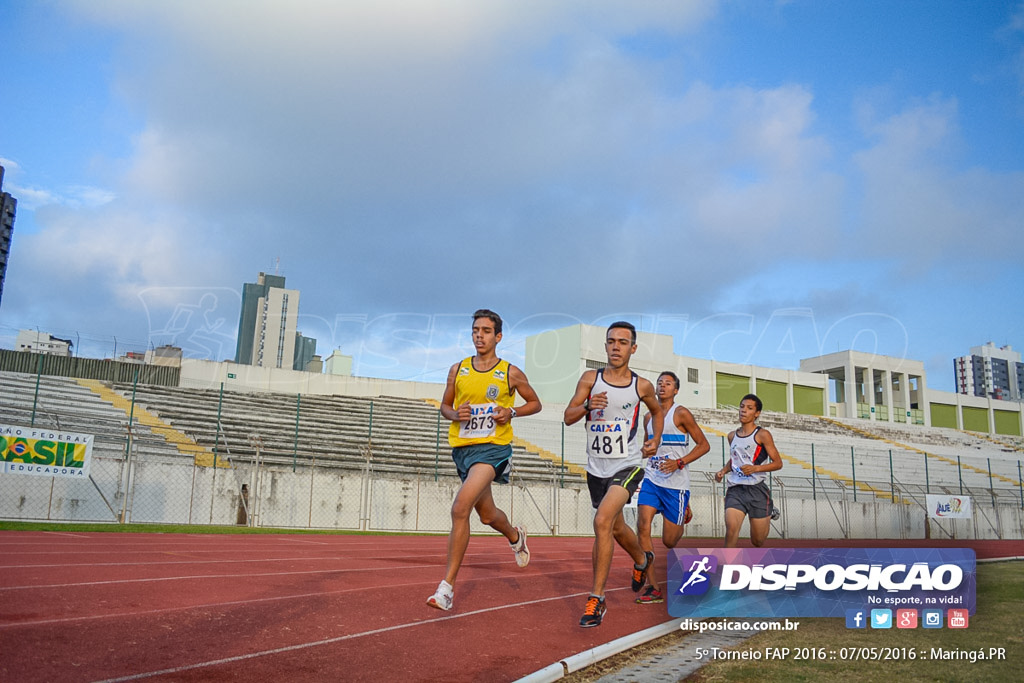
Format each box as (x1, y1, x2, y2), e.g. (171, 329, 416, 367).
(637, 371, 711, 603)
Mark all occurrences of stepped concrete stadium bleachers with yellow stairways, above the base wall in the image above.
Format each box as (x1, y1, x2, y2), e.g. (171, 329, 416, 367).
(0, 373, 1024, 527)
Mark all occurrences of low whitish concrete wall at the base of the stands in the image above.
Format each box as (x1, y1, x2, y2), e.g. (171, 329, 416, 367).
(6, 457, 1024, 539)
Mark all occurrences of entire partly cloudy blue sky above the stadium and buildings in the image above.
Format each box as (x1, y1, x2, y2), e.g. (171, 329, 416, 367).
(0, 0, 1024, 390)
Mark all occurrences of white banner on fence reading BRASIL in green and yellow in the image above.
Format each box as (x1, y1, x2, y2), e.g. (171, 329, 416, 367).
(0, 424, 93, 478)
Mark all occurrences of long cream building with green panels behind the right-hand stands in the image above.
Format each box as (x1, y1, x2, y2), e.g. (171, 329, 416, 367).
(525, 325, 1024, 436)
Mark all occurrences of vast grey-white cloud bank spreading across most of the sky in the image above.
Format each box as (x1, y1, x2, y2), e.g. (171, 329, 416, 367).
(5, 0, 1024, 374)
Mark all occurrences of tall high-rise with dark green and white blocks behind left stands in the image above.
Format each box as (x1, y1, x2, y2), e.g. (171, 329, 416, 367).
(234, 272, 299, 369)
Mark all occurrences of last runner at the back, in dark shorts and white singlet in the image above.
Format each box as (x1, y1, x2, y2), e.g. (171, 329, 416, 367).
(715, 393, 782, 548)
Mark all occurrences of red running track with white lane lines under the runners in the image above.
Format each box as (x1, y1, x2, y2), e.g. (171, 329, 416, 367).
(0, 531, 1024, 683)
